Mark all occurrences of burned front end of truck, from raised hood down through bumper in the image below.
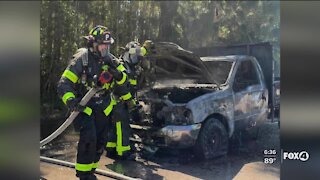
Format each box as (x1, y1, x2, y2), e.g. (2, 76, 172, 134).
(132, 42, 228, 148)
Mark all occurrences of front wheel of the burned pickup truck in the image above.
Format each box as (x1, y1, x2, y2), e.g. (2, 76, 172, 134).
(194, 118, 229, 159)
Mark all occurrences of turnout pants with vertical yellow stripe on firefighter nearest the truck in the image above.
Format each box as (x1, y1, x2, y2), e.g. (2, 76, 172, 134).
(106, 102, 131, 156)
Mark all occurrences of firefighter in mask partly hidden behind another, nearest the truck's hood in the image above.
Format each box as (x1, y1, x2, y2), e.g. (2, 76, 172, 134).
(106, 40, 158, 160)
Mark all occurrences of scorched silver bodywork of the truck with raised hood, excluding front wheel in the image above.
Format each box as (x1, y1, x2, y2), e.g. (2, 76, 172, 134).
(132, 42, 268, 148)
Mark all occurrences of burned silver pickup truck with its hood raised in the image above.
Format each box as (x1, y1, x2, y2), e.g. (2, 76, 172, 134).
(131, 42, 269, 159)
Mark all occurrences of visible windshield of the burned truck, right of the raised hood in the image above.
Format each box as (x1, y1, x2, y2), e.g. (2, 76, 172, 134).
(204, 61, 232, 84)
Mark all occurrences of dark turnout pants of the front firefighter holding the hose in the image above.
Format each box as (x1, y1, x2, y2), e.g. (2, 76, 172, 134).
(75, 97, 110, 179)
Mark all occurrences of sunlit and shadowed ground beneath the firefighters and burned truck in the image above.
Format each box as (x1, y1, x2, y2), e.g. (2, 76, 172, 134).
(40, 119, 280, 180)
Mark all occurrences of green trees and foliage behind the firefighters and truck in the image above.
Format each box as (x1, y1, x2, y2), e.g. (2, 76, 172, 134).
(40, 0, 280, 103)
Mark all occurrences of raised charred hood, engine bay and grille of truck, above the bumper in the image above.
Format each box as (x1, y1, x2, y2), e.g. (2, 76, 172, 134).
(138, 42, 225, 127)
